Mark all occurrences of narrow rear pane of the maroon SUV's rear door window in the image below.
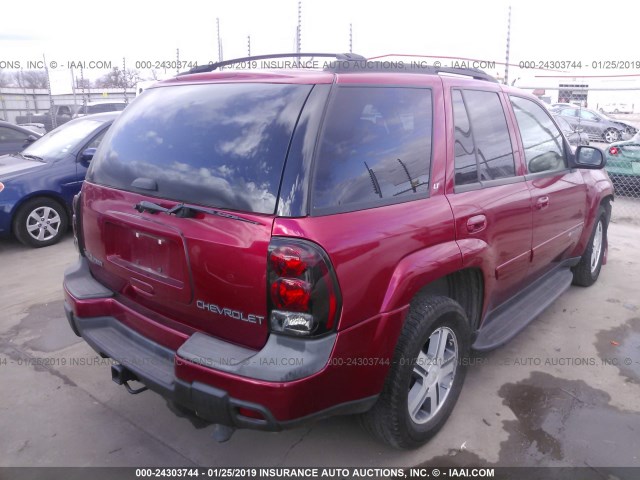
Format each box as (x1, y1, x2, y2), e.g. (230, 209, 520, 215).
(453, 90, 478, 185)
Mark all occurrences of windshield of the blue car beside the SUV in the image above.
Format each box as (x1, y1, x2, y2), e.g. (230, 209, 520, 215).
(22, 119, 103, 162)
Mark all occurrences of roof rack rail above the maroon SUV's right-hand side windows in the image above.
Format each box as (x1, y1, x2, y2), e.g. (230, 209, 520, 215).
(325, 60, 499, 83)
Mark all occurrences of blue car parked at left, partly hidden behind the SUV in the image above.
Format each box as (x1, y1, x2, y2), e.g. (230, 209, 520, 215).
(0, 112, 120, 247)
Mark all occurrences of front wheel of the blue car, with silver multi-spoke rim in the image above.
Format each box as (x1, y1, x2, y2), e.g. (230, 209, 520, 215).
(13, 197, 69, 248)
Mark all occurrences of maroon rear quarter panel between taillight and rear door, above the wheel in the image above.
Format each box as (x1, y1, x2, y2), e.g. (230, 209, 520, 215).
(273, 195, 461, 329)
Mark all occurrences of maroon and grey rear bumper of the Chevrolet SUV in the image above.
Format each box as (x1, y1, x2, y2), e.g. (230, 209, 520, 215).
(64, 258, 406, 431)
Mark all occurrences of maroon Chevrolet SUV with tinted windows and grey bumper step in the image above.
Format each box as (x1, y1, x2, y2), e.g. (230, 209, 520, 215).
(64, 55, 613, 447)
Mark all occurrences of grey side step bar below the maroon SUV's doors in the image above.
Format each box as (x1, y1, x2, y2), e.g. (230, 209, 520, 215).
(471, 265, 573, 352)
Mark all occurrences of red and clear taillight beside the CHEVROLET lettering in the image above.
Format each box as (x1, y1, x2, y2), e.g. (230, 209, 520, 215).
(267, 237, 341, 336)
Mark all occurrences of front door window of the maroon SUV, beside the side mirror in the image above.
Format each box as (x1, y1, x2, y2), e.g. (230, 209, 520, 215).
(511, 97, 565, 173)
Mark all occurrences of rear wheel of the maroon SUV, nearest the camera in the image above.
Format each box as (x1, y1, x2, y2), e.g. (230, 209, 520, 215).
(360, 294, 471, 448)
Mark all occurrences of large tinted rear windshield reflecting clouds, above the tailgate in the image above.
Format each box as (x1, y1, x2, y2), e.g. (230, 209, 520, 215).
(87, 83, 312, 214)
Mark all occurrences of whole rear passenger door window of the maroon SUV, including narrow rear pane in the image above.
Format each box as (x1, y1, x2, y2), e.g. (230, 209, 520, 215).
(454, 90, 515, 184)
